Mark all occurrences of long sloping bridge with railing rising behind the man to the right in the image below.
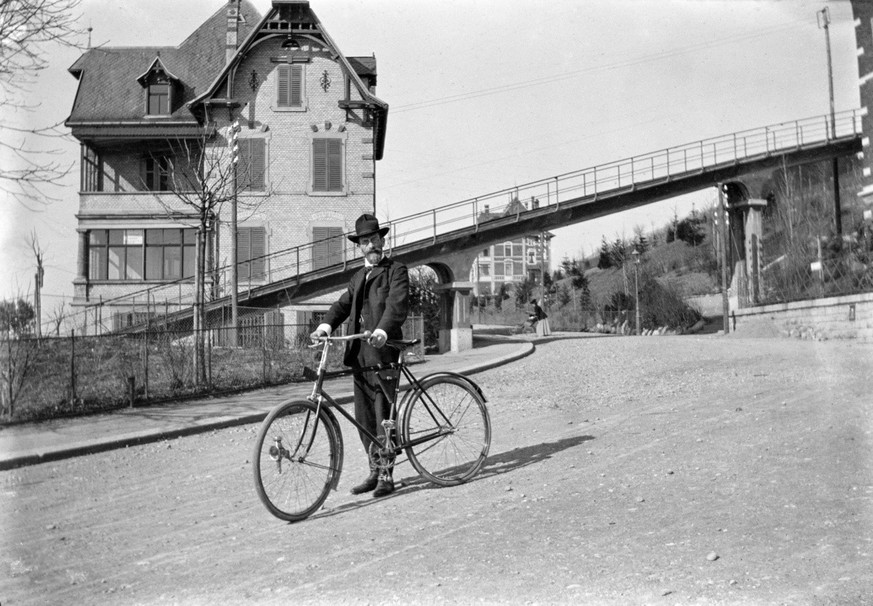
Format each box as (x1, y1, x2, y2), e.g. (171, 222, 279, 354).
(112, 110, 862, 350)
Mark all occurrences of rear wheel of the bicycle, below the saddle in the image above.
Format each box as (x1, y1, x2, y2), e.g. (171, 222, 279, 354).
(400, 376, 491, 486)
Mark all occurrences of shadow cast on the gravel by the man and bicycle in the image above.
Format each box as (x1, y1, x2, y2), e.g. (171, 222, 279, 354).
(312, 436, 594, 519)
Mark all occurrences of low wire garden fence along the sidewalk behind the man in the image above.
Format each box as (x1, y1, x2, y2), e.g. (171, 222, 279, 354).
(0, 316, 424, 422)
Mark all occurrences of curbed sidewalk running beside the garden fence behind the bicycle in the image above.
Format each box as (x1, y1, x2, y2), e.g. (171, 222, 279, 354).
(0, 337, 534, 470)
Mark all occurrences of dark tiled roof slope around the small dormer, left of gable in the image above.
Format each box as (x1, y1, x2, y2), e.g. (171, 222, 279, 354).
(66, 0, 261, 128)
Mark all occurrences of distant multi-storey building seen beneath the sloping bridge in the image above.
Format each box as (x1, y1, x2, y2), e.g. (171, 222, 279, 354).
(470, 198, 554, 297)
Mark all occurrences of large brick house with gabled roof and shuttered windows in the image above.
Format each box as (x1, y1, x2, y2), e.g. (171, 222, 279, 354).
(66, 0, 388, 331)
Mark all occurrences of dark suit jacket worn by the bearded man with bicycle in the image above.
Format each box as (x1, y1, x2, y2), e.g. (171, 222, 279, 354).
(324, 257, 409, 366)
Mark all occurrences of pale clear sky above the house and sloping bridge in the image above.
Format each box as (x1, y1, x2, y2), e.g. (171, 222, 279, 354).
(0, 0, 860, 313)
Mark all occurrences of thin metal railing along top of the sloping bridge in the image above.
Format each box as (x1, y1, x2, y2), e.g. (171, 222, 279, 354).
(80, 109, 862, 326)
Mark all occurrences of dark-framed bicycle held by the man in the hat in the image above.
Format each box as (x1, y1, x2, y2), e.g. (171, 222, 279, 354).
(253, 333, 491, 522)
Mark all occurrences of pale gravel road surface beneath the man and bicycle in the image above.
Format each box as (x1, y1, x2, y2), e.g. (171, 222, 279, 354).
(0, 335, 873, 606)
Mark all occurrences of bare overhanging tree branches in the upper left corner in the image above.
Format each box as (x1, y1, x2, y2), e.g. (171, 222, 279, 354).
(0, 0, 82, 205)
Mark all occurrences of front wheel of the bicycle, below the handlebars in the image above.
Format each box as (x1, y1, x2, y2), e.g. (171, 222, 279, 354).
(253, 400, 342, 522)
